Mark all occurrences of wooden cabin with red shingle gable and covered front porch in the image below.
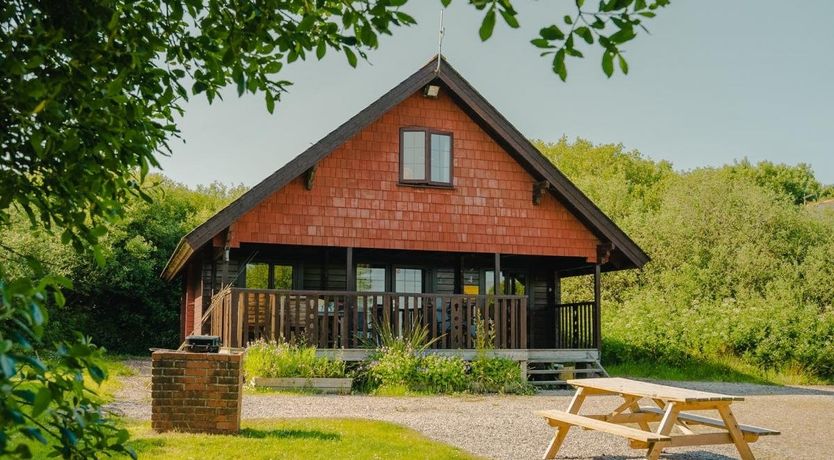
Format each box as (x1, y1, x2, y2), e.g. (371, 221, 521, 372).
(162, 57, 649, 380)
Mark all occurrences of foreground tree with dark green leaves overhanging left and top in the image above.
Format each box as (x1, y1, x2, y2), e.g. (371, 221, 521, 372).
(0, 0, 668, 457)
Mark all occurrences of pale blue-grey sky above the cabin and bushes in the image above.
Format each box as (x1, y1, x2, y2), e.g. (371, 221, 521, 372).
(162, 0, 834, 185)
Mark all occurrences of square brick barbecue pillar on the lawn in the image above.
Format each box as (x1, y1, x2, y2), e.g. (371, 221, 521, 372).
(151, 350, 243, 433)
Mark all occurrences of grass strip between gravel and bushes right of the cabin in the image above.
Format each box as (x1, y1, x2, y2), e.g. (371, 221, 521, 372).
(605, 357, 832, 385)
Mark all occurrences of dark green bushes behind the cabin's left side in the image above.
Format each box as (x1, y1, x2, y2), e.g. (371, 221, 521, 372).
(0, 175, 245, 354)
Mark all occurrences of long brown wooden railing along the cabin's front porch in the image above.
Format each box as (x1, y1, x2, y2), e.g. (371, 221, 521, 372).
(205, 288, 527, 349)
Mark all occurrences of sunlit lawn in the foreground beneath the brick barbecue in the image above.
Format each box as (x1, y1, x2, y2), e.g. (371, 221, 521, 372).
(27, 419, 477, 460)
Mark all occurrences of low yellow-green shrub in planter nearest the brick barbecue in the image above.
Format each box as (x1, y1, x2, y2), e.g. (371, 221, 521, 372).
(243, 340, 345, 378)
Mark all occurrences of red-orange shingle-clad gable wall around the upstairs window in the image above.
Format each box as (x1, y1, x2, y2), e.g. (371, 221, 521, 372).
(232, 93, 599, 261)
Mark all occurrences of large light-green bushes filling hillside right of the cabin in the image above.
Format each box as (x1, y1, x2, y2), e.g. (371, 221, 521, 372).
(537, 139, 834, 379)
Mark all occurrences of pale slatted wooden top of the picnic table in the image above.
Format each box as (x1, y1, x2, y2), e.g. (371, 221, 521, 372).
(568, 377, 744, 403)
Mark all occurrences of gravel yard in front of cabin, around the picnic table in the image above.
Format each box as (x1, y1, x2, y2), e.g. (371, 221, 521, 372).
(110, 366, 834, 460)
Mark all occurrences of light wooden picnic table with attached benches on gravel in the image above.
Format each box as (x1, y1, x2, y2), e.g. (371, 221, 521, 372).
(536, 378, 779, 460)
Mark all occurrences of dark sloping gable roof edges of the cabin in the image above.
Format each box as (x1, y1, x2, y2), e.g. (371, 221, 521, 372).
(162, 56, 649, 280)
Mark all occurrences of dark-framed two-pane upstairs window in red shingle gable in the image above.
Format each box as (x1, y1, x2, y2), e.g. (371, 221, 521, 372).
(400, 128, 452, 187)
